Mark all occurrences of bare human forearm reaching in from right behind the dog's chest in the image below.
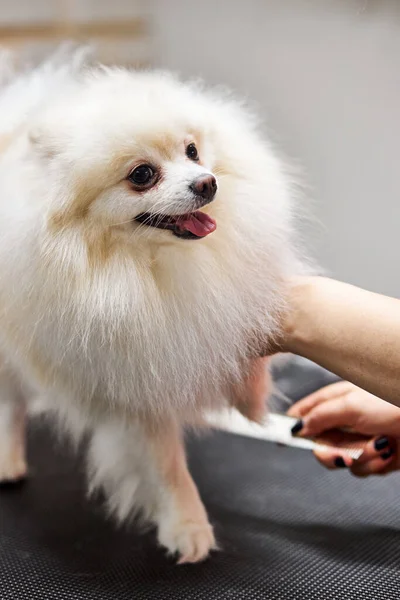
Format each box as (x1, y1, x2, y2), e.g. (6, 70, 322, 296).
(281, 277, 400, 406)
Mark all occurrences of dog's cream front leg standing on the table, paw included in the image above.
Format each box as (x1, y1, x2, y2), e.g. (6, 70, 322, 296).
(89, 420, 215, 564)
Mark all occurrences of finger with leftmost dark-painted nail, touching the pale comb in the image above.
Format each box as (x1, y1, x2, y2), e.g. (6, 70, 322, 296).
(292, 396, 358, 436)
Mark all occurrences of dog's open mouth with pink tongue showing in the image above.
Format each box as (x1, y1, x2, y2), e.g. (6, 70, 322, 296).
(135, 210, 217, 240)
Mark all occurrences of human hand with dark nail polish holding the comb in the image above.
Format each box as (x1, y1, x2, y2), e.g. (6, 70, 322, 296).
(288, 382, 400, 477)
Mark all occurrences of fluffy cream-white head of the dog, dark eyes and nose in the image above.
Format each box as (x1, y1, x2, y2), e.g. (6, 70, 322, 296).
(31, 70, 250, 258)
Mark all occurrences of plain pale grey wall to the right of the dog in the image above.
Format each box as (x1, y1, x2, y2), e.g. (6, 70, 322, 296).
(151, 0, 400, 296)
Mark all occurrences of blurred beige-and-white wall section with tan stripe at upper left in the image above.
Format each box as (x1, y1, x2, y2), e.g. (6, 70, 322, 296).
(0, 0, 150, 66)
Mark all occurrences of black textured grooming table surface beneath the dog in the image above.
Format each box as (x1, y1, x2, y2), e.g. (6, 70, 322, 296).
(0, 362, 400, 600)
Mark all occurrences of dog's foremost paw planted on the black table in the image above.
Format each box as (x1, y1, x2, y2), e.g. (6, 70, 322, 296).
(158, 521, 217, 565)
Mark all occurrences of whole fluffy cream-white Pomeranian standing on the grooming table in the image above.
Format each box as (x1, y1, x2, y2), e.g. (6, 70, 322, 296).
(0, 47, 303, 563)
